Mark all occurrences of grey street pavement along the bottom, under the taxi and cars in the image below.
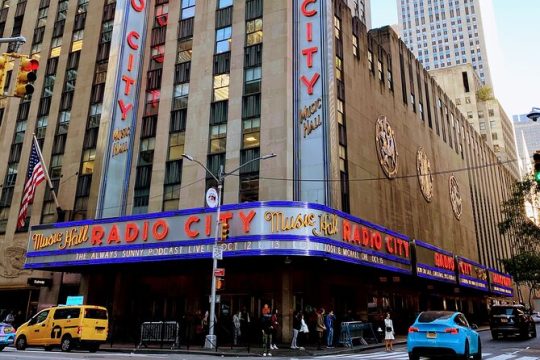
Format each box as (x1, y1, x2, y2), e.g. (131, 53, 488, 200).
(0, 331, 540, 360)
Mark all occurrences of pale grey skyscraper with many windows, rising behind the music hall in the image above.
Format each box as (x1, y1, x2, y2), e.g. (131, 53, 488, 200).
(396, 0, 492, 86)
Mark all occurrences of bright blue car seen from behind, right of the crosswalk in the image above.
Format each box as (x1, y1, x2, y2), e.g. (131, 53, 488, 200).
(407, 311, 482, 360)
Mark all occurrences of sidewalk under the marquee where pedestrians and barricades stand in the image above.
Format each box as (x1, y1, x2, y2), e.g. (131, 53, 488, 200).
(99, 335, 407, 357)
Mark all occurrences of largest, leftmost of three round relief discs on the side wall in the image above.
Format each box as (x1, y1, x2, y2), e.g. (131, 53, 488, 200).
(375, 116, 398, 179)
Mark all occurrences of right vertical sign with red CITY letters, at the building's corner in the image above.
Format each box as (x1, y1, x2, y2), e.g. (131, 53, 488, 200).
(293, 0, 333, 205)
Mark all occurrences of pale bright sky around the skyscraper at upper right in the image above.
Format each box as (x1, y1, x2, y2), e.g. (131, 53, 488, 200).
(371, 0, 540, 117)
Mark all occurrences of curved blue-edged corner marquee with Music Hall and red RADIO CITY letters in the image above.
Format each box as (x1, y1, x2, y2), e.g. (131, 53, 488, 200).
(25, 202, 412, 274)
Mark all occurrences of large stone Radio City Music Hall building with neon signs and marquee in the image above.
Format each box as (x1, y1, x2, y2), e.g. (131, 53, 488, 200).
(0, 0, 514, 339)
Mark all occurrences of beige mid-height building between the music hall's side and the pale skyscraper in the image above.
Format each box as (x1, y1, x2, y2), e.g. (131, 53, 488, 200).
(430, 64, 519, 177)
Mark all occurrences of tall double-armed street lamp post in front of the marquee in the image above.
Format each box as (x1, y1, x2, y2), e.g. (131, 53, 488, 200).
(182, 153, 277, 349)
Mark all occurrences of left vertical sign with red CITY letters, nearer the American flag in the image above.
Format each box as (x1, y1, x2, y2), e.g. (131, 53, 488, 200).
(96, 0, 148, 218)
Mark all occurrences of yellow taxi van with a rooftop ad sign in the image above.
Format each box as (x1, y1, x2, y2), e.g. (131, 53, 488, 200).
(15, 305, 109, 352)
